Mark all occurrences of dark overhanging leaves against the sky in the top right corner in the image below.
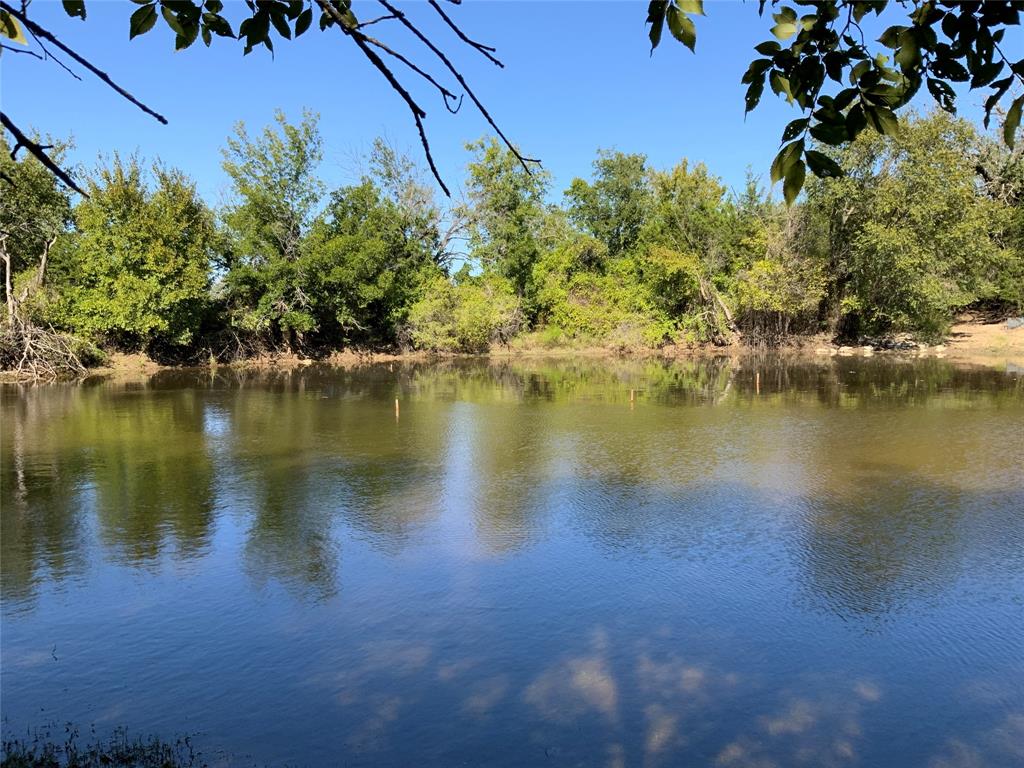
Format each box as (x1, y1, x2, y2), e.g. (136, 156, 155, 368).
(647, 0, 1024, 204)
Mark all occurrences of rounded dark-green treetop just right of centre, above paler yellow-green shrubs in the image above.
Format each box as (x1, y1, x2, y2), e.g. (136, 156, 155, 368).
(565, 150, 651, 258)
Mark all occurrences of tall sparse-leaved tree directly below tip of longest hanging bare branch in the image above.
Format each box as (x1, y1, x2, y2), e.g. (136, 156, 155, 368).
(465, 138, 549, 313)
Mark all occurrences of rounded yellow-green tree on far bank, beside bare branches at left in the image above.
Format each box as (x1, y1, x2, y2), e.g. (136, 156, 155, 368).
(46, 156, 218, 349)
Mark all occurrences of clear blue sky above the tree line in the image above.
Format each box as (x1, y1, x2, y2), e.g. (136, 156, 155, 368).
(0, 0, 1022, 204)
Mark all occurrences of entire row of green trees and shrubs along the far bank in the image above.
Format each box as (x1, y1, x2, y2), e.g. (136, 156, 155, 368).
(0, 112, 1024, 370)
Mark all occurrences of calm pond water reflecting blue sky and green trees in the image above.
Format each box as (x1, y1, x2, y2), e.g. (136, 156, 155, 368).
(0, 358, 1024, 768)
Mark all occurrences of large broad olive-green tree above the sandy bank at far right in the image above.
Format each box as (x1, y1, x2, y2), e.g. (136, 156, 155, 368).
(809, 112, 1001, 339)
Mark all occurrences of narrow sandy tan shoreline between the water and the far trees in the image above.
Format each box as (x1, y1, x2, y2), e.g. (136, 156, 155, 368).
(0, 322, 1024, 384)
